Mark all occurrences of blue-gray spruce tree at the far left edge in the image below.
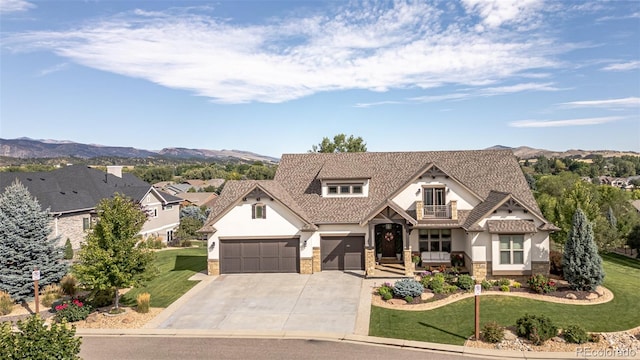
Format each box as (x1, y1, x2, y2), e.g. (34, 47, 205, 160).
(0, 181, 67, 301)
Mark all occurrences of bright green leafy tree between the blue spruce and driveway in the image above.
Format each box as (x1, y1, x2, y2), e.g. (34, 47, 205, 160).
(73, 194, 154, 309)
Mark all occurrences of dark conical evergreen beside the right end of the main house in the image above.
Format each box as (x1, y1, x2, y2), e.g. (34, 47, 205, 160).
(562, 208, 604, 291)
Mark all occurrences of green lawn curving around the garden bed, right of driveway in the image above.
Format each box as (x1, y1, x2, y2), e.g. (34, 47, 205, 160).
(369, 254, 640, 345)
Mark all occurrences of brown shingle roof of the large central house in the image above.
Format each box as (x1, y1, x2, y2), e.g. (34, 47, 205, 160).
(206, 150, 556, 229)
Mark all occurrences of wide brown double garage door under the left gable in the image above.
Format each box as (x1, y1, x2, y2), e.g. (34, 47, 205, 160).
(220, 239, 300, 274)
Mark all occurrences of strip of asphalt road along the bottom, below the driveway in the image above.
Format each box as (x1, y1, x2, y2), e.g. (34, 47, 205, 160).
(80, 336, 469, 360)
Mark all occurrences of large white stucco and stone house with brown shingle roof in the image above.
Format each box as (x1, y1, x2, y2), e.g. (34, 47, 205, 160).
(201, 150, 558, 279)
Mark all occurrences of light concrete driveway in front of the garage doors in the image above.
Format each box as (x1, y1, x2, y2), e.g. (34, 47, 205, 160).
(155, 271, 363, 334)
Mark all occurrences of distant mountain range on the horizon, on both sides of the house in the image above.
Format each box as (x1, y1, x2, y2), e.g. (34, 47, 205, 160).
(0, 137, 640, 163)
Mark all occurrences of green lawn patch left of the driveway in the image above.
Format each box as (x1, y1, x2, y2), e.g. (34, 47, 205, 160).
(122, 247, 207, 307)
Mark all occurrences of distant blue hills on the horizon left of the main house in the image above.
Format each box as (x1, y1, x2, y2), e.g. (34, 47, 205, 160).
(0, 138, 279, 163)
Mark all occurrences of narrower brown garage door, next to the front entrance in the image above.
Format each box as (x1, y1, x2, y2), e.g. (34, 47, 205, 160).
(320, 236, 364, 270)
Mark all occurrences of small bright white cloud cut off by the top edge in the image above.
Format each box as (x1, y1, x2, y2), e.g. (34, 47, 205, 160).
(462, 0, 543, 28)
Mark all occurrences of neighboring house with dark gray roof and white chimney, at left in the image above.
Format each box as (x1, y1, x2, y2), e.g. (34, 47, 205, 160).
(0, 165, 182, 249)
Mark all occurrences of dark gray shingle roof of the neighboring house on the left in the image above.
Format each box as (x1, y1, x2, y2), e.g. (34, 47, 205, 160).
(0, 165, 180, 213)
